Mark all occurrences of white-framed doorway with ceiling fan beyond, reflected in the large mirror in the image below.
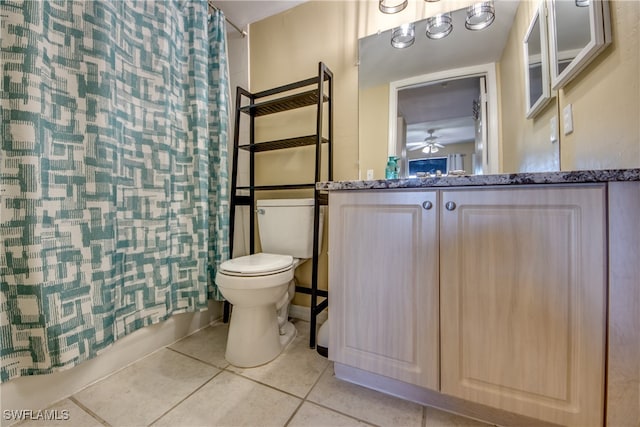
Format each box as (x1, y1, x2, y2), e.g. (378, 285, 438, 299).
(389, 64, 498, 178)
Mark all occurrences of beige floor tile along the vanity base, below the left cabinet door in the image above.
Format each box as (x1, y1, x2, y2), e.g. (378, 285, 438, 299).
(308, 367, 422, 427)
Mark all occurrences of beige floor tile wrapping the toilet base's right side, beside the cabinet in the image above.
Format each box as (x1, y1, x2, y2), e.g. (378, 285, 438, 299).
(227, 322, 329, 397)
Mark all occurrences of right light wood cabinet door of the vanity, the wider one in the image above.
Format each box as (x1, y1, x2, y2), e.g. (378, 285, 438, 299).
(440, 185, 607, 426)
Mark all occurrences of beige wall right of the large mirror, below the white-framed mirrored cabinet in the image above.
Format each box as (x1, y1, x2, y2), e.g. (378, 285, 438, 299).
(558, 0, 640, 170)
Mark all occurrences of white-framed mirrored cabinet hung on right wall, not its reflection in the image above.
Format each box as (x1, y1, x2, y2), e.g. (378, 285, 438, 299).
(549, 0, 611, 90)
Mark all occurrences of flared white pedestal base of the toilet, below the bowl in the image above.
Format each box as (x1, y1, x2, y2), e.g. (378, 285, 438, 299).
(224, 304, 297, 368)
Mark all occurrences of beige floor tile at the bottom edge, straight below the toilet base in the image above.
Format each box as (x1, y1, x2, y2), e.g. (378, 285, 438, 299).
(153, 372, 300, 427)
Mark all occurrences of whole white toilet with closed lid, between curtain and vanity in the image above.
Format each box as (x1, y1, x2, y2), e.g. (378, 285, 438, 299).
(216, 199, 323, 368)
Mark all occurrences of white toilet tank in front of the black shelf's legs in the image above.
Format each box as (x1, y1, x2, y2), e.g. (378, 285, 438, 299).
(256, 199, 324, 259)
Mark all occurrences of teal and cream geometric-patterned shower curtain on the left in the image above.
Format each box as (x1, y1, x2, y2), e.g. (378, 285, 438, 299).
(0, 0, 229, 382)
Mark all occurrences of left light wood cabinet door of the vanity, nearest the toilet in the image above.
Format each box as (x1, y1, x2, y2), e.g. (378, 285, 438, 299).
(329, 190, 439, 389)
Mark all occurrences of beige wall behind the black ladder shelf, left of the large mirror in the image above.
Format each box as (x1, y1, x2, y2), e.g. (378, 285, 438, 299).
(250, 2, 358, 183)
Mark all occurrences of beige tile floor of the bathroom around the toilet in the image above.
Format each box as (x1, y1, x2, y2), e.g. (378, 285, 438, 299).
(17, 321, 486, 427)
